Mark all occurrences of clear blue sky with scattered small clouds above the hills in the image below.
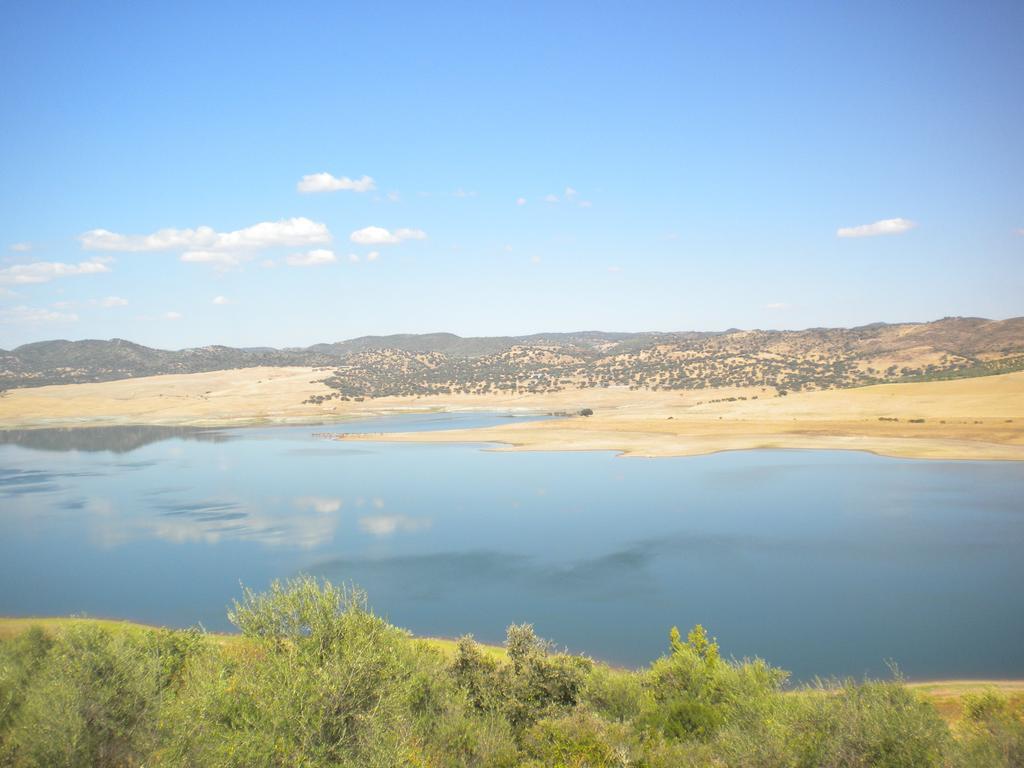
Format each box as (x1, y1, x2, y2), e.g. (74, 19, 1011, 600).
(0, 2, 1024, 348)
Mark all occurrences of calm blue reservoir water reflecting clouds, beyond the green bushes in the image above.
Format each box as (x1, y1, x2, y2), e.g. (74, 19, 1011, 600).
(0, 416, 1024, 679)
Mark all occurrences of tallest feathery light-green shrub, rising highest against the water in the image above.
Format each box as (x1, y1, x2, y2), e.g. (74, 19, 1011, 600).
(170, 578, 417, 768)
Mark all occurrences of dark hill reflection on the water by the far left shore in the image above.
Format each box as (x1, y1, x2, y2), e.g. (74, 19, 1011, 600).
(0, 426, 230, 454)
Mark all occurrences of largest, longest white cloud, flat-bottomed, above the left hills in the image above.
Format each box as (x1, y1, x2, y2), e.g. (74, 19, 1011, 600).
(79, 216, 331, 267)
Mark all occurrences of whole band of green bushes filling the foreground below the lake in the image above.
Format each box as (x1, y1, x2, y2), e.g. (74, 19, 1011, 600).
(0, 578, 1024, 768)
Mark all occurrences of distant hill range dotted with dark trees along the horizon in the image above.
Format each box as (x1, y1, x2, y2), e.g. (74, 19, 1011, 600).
(0, 317, 1024, 397)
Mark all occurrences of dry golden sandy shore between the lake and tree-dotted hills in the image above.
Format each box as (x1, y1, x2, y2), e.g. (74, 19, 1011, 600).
(0, 368, 1024, 461)
